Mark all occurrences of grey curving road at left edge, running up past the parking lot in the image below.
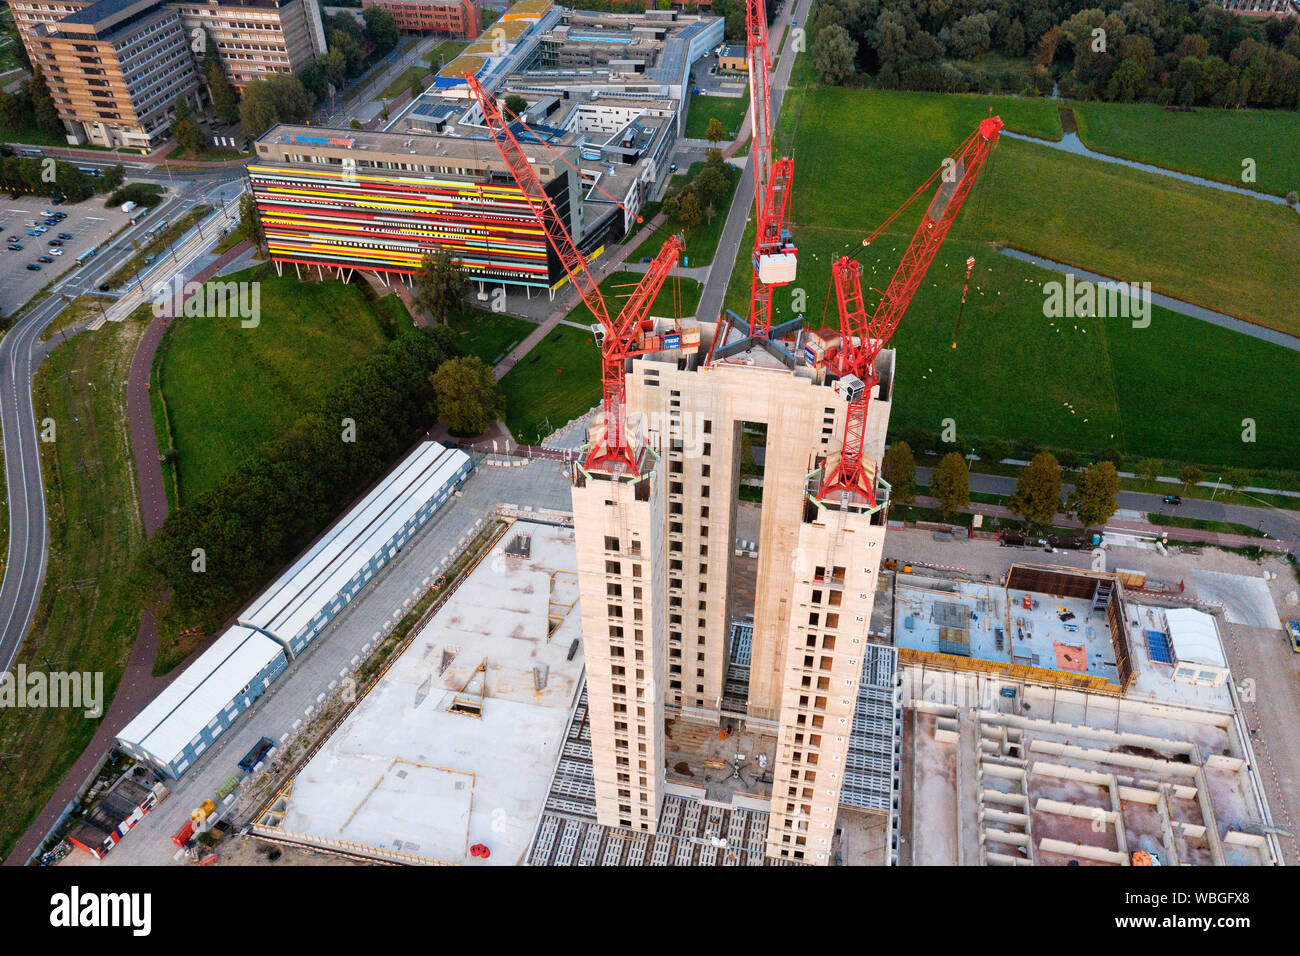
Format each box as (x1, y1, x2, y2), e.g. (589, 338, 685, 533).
(0, 172, 244, 670)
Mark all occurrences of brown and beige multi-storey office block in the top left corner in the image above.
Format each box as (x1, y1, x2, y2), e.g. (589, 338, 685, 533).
(12, 0, 325, 150)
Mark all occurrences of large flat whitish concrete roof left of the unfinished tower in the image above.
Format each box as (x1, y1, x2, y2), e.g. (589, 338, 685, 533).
(260, 522, 582, 866)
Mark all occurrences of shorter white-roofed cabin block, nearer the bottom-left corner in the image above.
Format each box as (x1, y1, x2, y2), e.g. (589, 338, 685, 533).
(117, 627, 287, 779)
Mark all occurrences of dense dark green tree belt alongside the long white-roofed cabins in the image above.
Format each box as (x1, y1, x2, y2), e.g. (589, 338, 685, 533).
(142, 328, 458, 631)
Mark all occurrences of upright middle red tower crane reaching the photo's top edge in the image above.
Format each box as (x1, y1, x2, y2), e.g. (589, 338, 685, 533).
(745, 0, 798, 338)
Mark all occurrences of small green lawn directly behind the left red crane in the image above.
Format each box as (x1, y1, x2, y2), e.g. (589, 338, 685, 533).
(501, 272, 702, 444)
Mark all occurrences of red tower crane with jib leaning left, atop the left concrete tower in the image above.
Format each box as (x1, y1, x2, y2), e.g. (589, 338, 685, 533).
(465, 73, 684, 473)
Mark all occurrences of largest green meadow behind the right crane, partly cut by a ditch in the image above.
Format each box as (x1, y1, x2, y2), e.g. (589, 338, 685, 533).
(727, 88, 1300, 468)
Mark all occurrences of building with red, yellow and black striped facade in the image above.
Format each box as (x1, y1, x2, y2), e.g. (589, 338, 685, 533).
(248, 125, 623, 290)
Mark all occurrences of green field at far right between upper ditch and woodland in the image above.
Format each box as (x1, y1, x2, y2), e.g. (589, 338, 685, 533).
(1070, 103, 1300, 196)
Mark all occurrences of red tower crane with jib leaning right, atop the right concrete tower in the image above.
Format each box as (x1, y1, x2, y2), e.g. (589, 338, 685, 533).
(819, 116, 1002, 507)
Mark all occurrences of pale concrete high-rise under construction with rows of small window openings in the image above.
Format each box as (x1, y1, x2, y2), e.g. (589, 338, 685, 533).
(573, 319, 894, 865)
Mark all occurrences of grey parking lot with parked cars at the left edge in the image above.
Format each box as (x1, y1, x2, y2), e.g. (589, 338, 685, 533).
(0, 194, 131, 315)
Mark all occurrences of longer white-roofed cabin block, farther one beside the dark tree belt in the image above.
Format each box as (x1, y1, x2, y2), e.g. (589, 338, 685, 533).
(239, 441, 471, 657)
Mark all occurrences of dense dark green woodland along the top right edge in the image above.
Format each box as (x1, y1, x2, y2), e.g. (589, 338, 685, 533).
(811, 0, 1300, 109)
